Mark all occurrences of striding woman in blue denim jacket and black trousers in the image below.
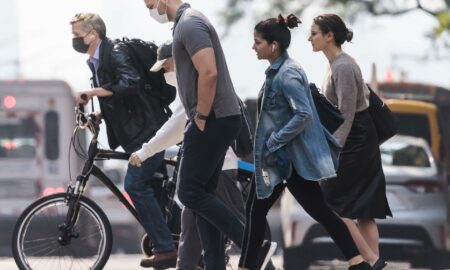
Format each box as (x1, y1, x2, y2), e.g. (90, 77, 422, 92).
(239, 14, 372, 270)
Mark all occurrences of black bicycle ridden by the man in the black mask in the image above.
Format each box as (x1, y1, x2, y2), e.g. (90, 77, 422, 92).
(12, 107, 180, 270)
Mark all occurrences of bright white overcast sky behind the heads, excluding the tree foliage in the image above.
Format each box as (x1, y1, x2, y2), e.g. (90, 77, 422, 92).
(0, 0, 450, 97)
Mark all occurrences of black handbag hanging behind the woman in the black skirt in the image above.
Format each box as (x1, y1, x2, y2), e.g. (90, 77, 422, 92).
(367, 86, 398, 144)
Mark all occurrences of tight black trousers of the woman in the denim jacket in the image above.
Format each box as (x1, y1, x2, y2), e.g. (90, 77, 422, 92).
(239, 170, 359, 269)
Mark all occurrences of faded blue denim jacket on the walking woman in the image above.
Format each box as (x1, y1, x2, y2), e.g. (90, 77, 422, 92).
(254, 52, 341, 199)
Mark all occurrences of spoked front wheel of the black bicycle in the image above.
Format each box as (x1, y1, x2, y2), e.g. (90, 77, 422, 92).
(12, 193, 112, 270)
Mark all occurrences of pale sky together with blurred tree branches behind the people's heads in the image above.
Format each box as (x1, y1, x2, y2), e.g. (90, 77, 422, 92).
(0, 0, 450, 97)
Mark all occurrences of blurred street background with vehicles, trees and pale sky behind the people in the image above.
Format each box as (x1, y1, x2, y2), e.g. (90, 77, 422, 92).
(0, 0, 450, 269)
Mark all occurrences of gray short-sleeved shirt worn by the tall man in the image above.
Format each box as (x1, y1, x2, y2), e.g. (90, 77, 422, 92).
(173, 8, 240, 118)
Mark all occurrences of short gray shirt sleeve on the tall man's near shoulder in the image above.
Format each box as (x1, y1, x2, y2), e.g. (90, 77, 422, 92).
(180, 16, 213, 57)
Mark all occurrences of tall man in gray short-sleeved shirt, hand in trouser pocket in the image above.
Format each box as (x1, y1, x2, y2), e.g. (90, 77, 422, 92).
(144, 0, 244, 270)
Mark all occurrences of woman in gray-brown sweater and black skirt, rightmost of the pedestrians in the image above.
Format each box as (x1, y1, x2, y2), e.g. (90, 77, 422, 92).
(309, 14, 392, 269)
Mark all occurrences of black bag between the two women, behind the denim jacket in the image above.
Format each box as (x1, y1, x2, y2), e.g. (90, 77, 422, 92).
(309, 83, 344, 134)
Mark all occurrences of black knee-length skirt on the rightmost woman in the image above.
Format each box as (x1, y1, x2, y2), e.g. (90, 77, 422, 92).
(321, 110, 392, 219)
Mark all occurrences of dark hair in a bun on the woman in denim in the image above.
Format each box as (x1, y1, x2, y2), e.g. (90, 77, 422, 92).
(255, 14, 302, 52)
